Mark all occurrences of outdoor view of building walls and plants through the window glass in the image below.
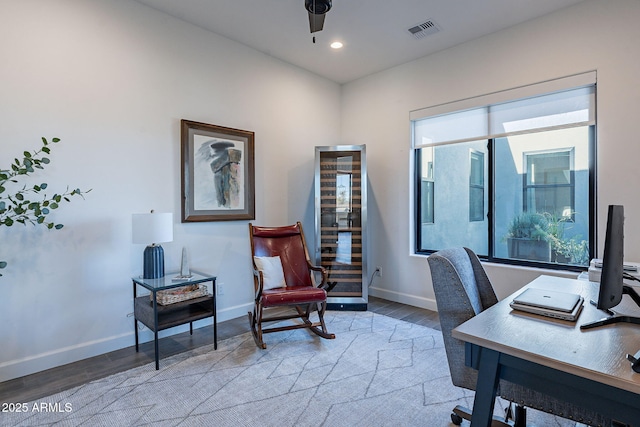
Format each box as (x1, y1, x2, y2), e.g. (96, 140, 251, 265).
(417, 126, 594, 266)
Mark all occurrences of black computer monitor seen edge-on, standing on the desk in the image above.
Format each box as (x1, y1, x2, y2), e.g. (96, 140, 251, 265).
(580, 205, 640, 329)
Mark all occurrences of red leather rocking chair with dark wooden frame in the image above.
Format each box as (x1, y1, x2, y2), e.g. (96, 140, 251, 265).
(249, 221, 335, 349)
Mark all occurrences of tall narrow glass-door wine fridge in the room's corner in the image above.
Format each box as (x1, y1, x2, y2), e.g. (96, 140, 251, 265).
(315, 145, 368, 310)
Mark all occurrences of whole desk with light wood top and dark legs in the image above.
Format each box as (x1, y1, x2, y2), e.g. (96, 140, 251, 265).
(452, 276, 640, 427)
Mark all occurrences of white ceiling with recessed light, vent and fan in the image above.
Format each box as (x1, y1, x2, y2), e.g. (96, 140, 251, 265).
(137, 0, 582, 83)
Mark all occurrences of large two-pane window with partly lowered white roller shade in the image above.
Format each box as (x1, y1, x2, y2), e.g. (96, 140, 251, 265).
(411, 73, 595, 270)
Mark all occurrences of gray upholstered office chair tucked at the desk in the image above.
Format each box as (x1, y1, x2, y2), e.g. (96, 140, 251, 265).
(427, 248, 611, 427)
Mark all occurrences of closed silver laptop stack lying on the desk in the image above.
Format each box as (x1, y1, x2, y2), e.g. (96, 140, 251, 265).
(509, 288, 584, 321)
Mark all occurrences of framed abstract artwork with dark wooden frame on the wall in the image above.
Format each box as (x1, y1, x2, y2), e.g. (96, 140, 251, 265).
(180, 119, 255, 222)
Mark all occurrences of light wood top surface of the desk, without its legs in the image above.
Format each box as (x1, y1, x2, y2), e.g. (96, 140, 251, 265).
(452, 276, 640, 394)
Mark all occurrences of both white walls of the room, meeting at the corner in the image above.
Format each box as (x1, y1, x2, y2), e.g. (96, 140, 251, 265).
(0, 0, 640, 381)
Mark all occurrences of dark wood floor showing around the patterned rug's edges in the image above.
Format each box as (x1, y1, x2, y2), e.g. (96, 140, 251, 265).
(0, 297, 440, 403)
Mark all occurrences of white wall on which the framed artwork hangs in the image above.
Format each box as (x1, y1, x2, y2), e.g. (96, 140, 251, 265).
(0, 0, 340, 381)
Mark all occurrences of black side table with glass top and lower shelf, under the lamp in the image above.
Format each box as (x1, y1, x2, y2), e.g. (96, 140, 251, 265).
(132, 272, 218, 370)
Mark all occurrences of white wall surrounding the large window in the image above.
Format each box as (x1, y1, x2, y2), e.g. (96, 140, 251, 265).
(342, 0, 640, 308)
